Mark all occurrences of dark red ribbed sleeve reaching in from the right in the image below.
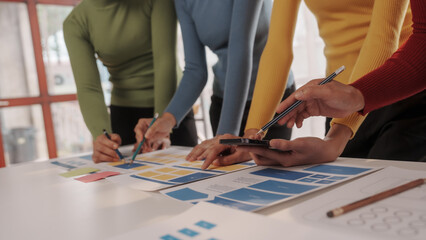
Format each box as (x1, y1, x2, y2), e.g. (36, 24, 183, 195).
(350, 0, 426, 114)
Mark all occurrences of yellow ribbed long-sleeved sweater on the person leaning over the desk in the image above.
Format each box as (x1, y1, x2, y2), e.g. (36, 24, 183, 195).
(246, 0, 412, 135)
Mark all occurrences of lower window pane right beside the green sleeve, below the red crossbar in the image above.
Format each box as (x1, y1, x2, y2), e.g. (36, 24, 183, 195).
(51, 101, 92, 157)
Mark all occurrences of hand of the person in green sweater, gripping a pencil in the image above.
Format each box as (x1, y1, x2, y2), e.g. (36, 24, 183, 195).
(92, 133, 121, 163)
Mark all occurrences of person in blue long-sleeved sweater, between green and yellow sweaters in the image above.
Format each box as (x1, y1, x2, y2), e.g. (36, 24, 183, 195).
(135, 0, 295, 151)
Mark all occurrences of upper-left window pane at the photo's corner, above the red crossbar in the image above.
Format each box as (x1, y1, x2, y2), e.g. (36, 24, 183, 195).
(0, 2, 39, 98)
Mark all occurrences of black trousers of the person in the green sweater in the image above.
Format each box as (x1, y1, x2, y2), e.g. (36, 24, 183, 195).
(110, 105, 198, 147)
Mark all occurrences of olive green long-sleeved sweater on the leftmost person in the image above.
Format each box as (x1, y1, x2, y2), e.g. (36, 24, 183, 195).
(63, 0, 179, 138)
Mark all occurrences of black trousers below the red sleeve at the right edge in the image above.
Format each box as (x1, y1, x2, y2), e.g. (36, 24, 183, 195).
(326, 91, 426, 162)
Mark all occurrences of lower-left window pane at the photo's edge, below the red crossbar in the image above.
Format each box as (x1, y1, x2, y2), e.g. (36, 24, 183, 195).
(0, 105, 48, 165)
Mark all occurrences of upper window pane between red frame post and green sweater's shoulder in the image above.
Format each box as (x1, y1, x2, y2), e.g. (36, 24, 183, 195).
(37, 4, 76, 95)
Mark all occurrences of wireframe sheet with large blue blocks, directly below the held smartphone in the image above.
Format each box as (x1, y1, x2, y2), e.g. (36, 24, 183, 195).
(161, 163, 377, 211)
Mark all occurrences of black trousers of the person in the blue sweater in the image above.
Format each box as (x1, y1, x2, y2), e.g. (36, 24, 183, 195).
(209, 84, 296, 140)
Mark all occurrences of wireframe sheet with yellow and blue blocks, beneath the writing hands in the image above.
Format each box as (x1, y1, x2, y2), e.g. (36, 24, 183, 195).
(51, 146, 255, 188)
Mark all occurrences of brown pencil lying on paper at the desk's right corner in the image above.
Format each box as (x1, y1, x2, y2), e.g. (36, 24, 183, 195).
(327, 178, 426, 218)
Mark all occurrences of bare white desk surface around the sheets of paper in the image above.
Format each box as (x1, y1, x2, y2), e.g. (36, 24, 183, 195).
(0, 155, 426, 240)
